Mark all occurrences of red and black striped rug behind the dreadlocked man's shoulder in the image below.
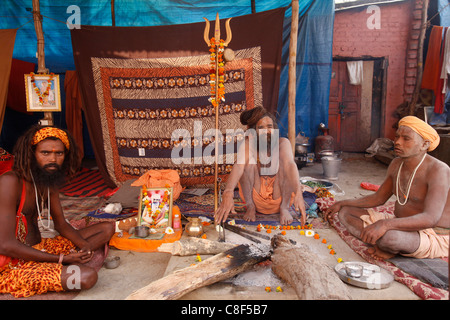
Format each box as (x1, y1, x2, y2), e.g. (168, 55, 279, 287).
(60, 168, 115, 197)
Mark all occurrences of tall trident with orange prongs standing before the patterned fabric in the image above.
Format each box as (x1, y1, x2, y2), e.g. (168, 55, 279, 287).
(203, 13, 231, 241)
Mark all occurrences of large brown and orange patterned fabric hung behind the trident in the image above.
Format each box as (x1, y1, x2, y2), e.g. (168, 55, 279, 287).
(72, 9, 284, 186)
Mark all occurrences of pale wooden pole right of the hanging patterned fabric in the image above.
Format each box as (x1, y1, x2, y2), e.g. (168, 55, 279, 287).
(288, 0, 299, 154)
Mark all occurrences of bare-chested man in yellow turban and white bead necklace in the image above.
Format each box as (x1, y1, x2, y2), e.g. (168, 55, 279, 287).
(325, 116, 450, 259)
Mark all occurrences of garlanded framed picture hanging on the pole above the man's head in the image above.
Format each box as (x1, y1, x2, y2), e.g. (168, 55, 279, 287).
(25, 73, 61, 112)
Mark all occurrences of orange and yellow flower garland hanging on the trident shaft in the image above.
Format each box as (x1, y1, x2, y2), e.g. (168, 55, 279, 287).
(208, 38, 225, 107)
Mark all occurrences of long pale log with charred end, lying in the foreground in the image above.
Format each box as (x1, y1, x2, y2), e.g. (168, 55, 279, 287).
(126, 245, 270, 300)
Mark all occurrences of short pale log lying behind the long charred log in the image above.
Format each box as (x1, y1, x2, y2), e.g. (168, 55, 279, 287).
(158, 237, 236, 256)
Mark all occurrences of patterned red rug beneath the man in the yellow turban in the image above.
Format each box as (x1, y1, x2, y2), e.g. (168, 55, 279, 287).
(318, 198, 449, 300)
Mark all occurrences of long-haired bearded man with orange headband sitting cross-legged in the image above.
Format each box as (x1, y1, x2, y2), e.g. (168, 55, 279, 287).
(0, 126, 114, 297)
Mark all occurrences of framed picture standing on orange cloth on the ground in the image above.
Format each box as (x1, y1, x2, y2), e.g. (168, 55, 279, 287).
(138, 186, 173, 232)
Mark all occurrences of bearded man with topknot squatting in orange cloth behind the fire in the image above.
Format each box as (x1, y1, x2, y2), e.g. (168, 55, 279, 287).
(215, 107, 306, 225)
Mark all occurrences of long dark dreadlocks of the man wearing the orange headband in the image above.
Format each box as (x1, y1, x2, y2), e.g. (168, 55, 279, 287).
(13, 125, 81, 181)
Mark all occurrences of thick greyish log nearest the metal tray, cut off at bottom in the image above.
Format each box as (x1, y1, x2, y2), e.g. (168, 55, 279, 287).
(271, 235, 351, 300)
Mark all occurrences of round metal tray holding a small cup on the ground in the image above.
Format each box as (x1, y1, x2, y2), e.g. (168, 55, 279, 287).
(334, 261, 394, 289)
